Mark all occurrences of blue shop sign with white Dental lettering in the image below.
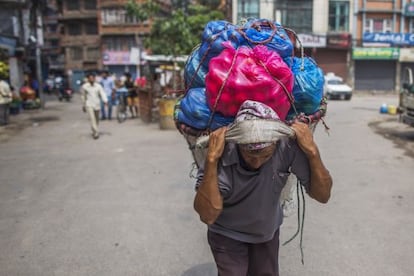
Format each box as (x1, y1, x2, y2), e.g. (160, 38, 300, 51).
(362, 33, 414, 46)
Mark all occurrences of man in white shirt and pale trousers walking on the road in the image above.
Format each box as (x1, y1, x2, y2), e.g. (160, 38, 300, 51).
(80, 73, 108, 139)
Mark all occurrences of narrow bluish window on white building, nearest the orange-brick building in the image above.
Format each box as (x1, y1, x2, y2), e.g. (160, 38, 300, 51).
(328, 1, 349, 32)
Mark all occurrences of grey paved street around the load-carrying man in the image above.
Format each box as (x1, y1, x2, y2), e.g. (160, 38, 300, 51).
(0, 95, 414, 276)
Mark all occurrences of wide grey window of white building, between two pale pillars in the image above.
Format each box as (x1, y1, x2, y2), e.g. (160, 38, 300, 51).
(276, 0, 313, 33)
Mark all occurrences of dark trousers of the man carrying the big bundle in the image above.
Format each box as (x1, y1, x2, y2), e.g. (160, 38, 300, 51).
(207, 230, 279, 276)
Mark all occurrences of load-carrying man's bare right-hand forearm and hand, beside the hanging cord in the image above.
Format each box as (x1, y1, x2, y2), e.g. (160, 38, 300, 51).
(292, 123, 332, 203)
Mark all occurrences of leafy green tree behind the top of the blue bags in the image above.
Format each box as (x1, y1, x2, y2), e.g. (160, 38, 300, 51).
(127, 0, 224, 56)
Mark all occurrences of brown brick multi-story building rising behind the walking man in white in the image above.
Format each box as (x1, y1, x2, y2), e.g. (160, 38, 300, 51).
(58, 0, 102, 79)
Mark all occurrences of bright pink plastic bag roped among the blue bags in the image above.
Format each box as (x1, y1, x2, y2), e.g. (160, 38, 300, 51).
(206, 42, 294, 120)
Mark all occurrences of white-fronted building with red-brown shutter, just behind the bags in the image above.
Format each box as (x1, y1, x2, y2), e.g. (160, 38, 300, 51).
(233, 0, 353, 83)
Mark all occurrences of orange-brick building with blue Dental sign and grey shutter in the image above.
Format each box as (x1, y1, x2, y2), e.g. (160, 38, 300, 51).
(352, 0, 414, 91)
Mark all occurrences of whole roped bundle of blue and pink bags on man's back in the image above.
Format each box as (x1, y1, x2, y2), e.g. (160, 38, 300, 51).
(174, 19, 326, 153)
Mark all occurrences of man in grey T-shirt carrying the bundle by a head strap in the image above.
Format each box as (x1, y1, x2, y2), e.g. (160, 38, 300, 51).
(194, 101, 332, 276)
